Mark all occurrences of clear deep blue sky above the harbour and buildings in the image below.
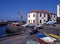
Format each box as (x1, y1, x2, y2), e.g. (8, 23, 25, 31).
(0, 0, 60, 21)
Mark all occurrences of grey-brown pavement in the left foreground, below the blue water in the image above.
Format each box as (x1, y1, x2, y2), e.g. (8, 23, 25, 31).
(0, 34, 27, 44)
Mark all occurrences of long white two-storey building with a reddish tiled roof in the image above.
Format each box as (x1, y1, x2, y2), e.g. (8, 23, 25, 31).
(27, 10, 57, 25)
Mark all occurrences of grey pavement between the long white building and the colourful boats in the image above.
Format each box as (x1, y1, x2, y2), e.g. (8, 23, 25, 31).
(39, 25, 60, 34)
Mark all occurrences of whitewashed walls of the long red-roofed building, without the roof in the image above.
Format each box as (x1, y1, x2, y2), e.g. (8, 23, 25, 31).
(27, 12, 57, 25)
